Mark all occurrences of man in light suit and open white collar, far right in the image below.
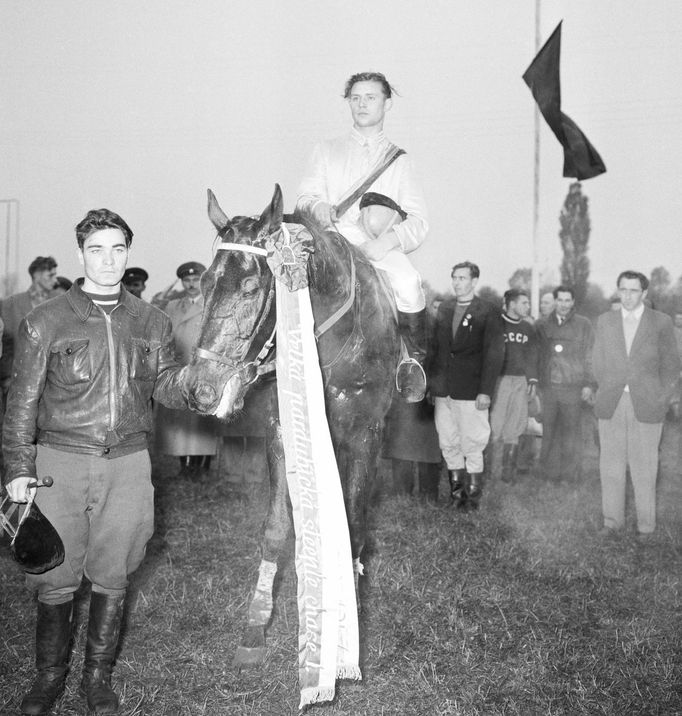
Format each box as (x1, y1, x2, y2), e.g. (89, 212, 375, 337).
(593, 271, 680, 539)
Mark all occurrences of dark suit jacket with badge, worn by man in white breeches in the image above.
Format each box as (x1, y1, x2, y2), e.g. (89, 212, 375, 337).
(427, 296, 504, 400)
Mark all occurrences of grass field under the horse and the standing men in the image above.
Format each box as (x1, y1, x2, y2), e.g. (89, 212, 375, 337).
(0, 425, 682, 716)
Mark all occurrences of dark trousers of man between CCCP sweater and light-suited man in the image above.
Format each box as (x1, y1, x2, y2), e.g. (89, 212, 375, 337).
(540, 388, 583, 482)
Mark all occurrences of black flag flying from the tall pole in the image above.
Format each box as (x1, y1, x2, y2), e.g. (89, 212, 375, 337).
(523, 23, 606, 180)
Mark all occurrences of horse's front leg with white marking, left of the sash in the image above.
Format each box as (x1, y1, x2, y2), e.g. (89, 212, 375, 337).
(234, 418, 292, 667)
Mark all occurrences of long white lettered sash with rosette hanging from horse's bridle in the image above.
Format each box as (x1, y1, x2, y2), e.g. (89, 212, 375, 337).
(269, 225, 362, 708)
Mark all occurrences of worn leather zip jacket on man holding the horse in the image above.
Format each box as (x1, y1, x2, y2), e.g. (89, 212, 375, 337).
(3, 283, 186, 482)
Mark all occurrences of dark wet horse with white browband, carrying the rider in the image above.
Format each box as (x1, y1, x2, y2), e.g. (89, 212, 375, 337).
(186, 186, 400, 663)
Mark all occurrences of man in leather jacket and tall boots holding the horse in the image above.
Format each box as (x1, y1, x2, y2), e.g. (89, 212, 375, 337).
(3, 209, 186, 714)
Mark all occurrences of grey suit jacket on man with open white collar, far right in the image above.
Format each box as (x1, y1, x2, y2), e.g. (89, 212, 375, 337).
(592, 308, 680, 423)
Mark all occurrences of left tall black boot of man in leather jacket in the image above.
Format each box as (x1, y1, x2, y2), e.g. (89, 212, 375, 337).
(21, 600, 73, 716)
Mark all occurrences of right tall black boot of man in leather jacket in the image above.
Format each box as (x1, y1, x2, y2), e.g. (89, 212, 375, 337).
(80, 592, 125, 714)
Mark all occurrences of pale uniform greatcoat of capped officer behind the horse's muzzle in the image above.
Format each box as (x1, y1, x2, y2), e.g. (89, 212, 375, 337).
(156, 296, 218, 456)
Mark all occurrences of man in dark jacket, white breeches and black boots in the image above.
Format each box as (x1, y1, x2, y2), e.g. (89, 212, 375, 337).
(427, 261, 504, 509)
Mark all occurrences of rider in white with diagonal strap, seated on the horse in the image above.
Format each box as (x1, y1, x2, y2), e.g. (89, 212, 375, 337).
(297, 72, 428, 402)
